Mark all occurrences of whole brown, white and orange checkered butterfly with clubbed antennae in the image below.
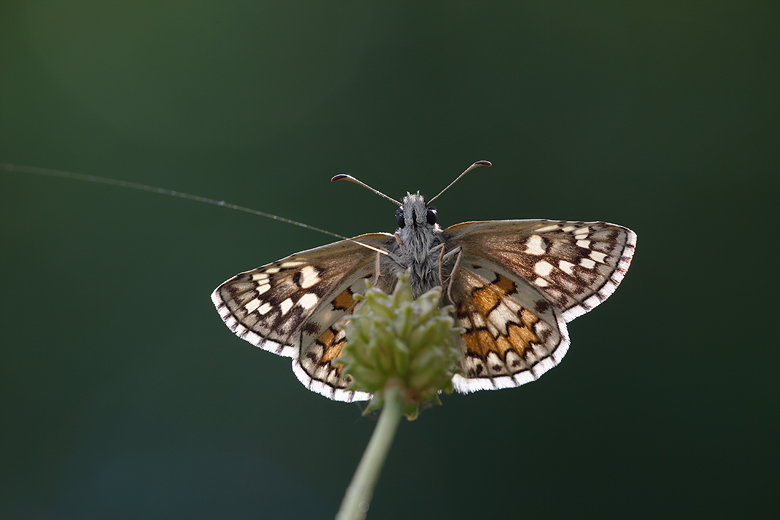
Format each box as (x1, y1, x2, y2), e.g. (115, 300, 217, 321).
(211, 161, 636, 402)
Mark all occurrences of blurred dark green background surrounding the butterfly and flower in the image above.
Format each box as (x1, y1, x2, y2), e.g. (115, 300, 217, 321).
(0, 0, 780, 520)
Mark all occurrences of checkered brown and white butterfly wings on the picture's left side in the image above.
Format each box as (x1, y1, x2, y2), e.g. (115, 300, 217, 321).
(211, 233, 395, 401)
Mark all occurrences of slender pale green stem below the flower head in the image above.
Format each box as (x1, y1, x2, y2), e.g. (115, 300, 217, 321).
(336, 388, 401, 520)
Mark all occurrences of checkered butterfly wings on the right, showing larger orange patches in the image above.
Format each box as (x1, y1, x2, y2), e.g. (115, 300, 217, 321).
(443, 220, 636, 392)
